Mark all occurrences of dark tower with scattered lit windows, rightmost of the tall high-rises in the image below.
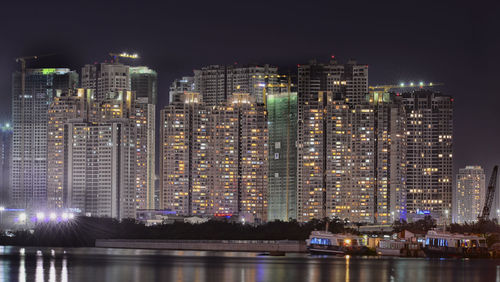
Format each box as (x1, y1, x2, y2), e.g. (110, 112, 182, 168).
(402, 90, 453, 222)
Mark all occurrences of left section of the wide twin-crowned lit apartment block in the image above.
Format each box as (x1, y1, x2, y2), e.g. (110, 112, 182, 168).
(160, 92, 206, 215)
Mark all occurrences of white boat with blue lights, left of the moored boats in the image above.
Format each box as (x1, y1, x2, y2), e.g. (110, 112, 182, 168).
(306, 231, 366, 255)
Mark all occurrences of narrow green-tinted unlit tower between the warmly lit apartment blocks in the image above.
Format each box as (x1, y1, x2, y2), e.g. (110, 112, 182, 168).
(266, 89, 297, 221)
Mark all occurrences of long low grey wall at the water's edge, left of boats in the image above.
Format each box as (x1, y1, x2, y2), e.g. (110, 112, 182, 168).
(95, 239, 307, 254)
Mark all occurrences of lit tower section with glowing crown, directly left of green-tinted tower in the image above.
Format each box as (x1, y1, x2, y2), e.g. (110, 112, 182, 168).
(211, 93, 268, 222)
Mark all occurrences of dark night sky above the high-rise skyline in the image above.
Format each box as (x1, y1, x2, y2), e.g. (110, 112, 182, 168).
(0, 0, 500, 178)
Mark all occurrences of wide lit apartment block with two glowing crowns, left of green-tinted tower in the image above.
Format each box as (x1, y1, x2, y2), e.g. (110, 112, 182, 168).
(160, 92, 268, 222)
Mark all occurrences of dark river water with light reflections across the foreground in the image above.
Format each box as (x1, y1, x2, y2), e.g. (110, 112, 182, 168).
(0, 246, 500, 282)
